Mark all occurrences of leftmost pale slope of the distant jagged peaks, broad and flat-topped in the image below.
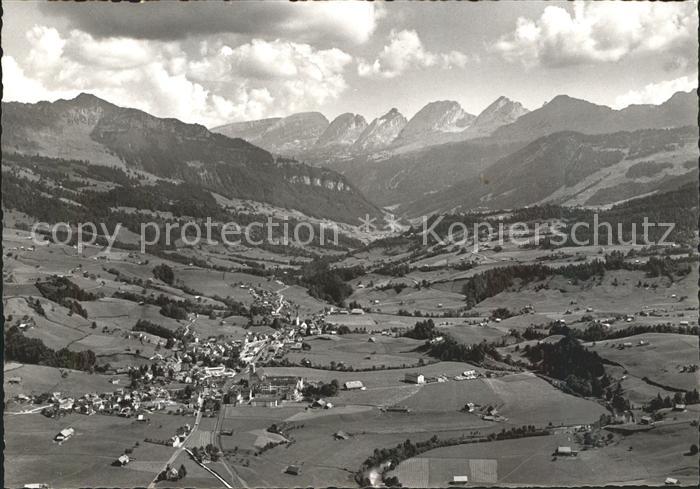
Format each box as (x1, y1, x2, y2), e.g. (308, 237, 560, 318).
(212, 112, 329, 156)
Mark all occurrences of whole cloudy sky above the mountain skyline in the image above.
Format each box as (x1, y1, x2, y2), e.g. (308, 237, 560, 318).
(2, 1, 698, 127)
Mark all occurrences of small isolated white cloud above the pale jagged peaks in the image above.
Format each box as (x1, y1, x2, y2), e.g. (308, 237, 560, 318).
(357, 30, 469, 78)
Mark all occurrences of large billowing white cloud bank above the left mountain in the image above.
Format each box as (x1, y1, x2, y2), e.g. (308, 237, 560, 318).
(3, 26, 352, 126)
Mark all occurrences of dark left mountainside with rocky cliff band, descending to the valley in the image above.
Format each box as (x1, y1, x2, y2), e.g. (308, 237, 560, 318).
(2, 94, 379, 223)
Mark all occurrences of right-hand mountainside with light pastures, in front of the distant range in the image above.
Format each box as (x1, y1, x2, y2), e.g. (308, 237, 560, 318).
(402, 126, 698, 215)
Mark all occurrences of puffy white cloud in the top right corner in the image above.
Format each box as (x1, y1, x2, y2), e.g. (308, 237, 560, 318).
(493, 2, 697, 67)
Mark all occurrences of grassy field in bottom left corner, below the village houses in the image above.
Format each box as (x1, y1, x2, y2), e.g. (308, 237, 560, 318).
(5, 414, 193, 487)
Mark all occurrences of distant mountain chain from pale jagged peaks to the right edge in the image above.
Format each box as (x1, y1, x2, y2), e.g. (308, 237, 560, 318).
(212, 92, 697, 160)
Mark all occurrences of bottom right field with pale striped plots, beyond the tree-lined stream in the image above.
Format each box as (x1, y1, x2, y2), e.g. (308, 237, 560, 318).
(394, 423, 698, 487)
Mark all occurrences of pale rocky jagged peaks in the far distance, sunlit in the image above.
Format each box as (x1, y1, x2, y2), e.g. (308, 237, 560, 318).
(212, 97, 527, 156)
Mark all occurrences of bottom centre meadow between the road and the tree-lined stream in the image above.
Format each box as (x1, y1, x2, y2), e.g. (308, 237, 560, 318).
(222, 407, 498, 487)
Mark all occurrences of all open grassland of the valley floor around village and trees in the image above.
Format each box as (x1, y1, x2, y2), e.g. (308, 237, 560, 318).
(3, 218, 700, 487)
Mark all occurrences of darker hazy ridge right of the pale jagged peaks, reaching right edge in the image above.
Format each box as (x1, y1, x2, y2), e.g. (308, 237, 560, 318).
(492, 92, 698, 141)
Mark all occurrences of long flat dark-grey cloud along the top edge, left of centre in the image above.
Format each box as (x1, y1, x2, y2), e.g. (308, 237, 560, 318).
(41, 1, 384, 43)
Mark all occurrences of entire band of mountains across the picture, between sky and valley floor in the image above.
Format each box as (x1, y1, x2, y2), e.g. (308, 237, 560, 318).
(2, 92, 698, 223)
